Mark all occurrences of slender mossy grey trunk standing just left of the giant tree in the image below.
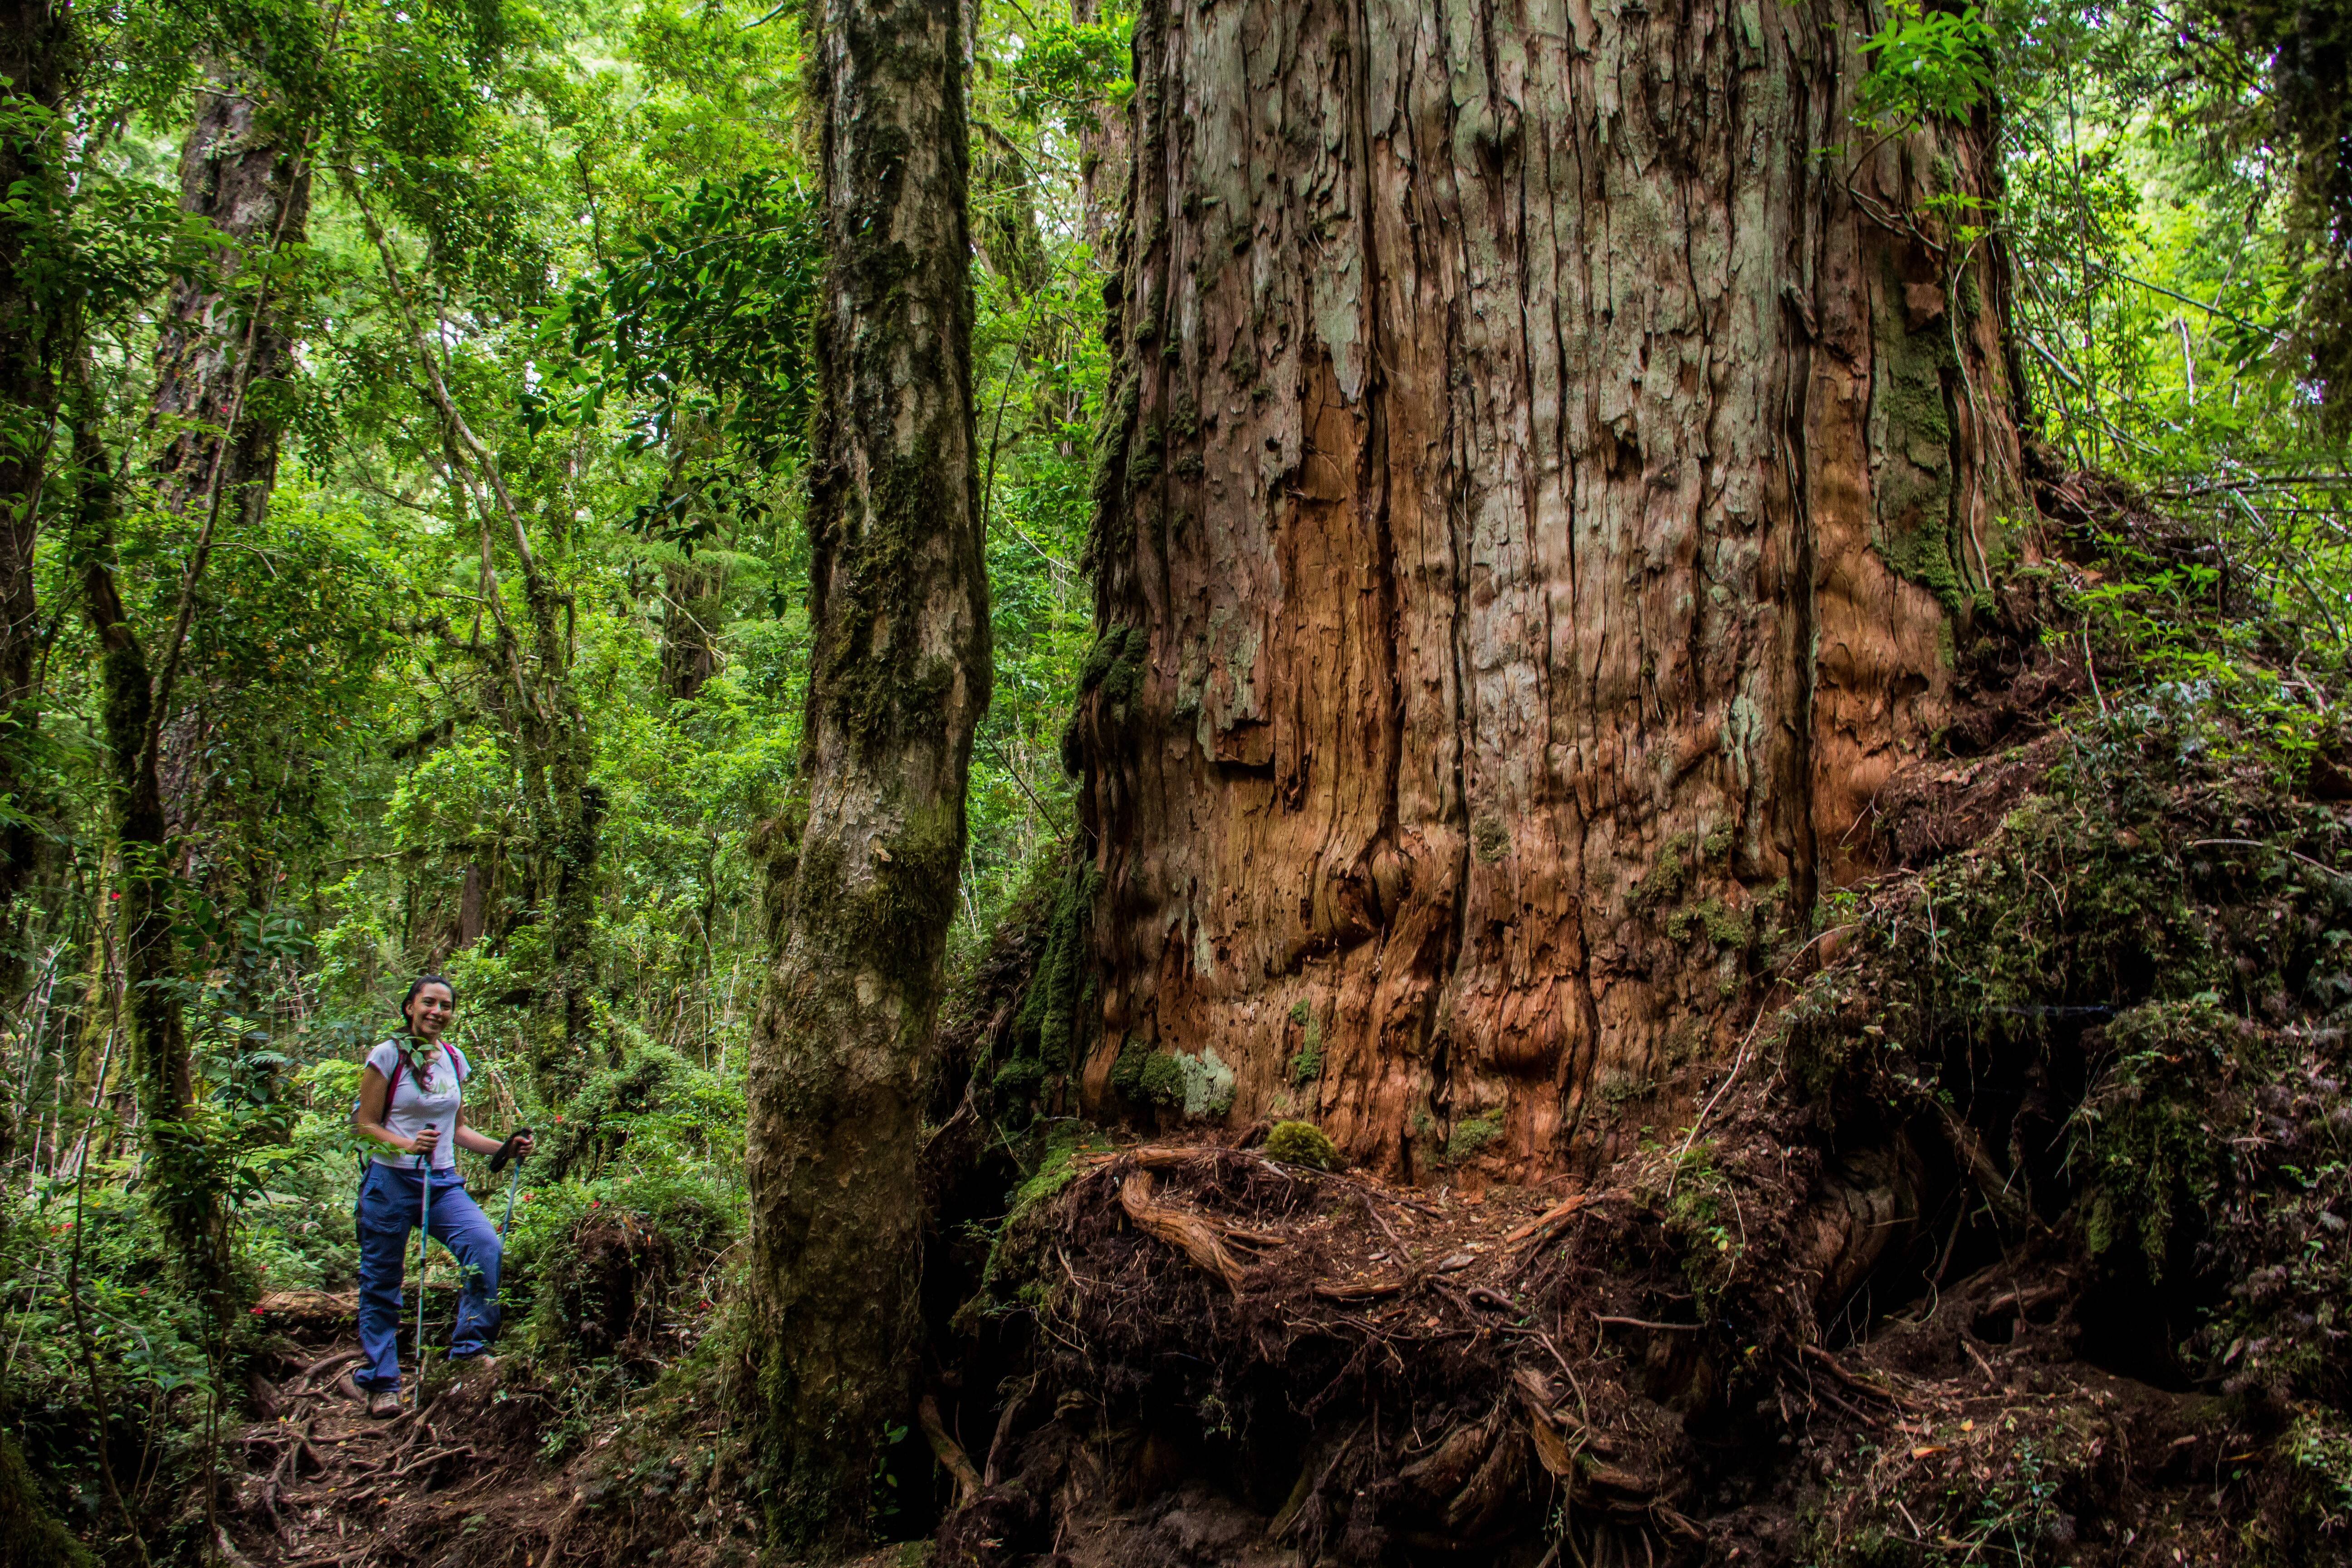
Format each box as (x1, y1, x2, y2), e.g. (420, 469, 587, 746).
(748, 0, 990, 1552)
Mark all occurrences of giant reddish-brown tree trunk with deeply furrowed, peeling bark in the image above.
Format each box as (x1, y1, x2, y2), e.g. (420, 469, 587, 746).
(1077, 0, 2023, 1173)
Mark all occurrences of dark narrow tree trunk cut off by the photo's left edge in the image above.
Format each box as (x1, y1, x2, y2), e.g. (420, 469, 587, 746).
(0, 0, 73, 959)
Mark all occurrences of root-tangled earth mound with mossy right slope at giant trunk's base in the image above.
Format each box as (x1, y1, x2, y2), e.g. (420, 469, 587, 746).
(941, 677, 2352, 1568)
